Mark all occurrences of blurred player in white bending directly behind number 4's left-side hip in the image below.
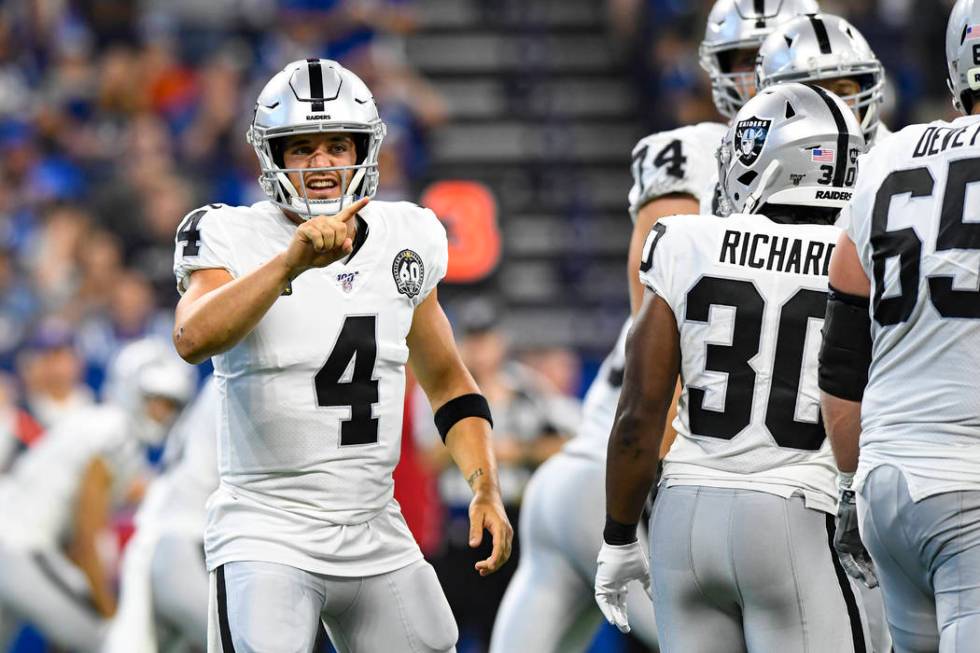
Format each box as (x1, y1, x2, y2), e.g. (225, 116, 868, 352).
(103, 377, 218, 653)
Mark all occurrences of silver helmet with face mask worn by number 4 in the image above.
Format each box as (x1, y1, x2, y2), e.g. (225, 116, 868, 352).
(246, 59, 385, 219)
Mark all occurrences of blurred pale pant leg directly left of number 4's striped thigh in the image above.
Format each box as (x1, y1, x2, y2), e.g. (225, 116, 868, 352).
(150, 535, 208, 648)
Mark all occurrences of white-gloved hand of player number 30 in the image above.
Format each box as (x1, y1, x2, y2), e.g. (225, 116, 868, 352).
(595, 541, 653, 633)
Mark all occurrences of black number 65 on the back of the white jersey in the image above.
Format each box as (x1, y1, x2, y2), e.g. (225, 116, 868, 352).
(870, 158, 980, 326)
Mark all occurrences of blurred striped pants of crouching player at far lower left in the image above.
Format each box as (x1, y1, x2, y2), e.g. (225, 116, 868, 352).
(0, 547, 108, 651)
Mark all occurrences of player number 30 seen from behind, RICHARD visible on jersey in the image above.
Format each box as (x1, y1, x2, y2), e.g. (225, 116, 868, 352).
(595, 84, 884, 652)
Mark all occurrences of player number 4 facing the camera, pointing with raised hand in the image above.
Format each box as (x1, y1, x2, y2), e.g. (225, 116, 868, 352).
(174, 59, 512, 653)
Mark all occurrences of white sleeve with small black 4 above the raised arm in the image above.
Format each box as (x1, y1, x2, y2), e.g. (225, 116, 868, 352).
(174, 204, 239, 294)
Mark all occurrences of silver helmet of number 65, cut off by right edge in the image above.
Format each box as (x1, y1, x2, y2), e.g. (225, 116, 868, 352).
(946, 0, 980, 114)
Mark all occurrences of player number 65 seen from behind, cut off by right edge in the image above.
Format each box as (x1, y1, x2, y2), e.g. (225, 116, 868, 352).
(820, 0, 980, 652)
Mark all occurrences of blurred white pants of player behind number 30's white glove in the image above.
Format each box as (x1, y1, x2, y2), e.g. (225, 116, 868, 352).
(490, 452, 657, 653)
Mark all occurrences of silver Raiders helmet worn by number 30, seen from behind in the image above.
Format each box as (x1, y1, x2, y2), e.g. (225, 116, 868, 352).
(718, 83, 864, 213)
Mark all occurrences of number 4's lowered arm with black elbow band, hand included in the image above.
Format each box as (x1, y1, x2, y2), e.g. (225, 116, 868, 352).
(408, 290, 514, 576)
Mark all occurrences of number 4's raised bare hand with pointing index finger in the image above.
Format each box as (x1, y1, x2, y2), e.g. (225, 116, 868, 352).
(283, 197, 368, 279)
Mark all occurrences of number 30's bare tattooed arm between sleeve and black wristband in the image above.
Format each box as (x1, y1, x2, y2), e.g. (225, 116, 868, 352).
(606, 291, 680, 524)
